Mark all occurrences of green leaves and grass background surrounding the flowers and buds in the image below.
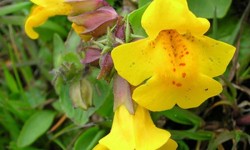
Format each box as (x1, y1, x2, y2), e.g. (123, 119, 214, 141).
(0, 0, 250, 150)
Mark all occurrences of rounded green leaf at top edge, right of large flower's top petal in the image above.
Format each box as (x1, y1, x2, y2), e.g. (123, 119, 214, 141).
(187, 0, 232, 19)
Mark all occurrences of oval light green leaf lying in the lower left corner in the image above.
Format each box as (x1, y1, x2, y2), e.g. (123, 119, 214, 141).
(17, 110, 55, 147)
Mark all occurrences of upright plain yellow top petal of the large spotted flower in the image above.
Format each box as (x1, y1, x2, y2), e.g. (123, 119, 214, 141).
(142, 0, 210, 38)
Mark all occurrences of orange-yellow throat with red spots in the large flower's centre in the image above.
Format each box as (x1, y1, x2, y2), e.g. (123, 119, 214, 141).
(151, 30, 197, 87)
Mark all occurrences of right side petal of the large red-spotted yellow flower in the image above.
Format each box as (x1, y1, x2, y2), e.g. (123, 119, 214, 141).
(187, 36, 235, 77)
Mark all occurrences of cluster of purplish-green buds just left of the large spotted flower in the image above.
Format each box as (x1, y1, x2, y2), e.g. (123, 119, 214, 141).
(82, 17, 126, 82)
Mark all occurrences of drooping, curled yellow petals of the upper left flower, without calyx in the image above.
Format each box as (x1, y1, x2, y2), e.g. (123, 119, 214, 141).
(25, 0, 72, 39)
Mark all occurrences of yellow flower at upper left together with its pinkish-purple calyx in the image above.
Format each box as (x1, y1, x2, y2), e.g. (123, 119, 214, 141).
(25, 0, 118, 39)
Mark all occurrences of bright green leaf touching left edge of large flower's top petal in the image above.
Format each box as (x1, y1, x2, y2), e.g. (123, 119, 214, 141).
(128, 3, 149, 37)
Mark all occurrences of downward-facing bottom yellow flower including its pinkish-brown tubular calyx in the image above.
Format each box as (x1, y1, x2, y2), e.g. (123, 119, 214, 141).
(94, 74, 177, 150)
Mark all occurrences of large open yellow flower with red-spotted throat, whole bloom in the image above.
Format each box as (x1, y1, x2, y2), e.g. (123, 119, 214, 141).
(112, 0, 235, 111)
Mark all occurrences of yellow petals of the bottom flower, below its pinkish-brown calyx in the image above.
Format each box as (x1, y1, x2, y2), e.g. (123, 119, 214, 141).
(94, 105, 177, 150)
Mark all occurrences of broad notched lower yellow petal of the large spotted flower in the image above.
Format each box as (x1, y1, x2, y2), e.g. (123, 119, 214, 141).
(133, 74, 222, 111)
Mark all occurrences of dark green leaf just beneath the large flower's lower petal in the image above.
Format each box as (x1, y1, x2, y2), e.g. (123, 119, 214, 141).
(161, 106, 204, 127)
